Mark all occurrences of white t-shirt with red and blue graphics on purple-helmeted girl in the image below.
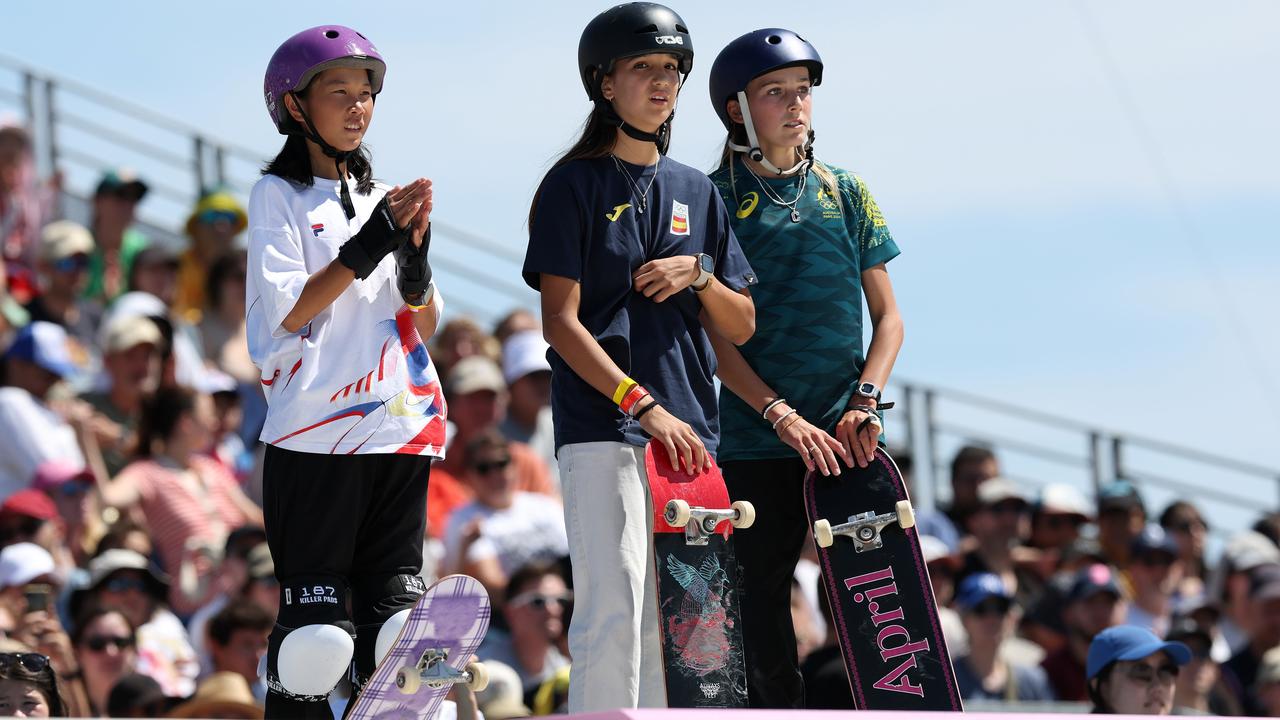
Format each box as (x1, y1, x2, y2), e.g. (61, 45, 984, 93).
(244, 176, 445, 457)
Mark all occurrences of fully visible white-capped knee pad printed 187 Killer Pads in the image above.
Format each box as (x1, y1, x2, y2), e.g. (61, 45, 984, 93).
(266, 577, 356, 700)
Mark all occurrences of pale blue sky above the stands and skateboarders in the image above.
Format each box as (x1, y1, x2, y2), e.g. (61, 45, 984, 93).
(4, 0, 1280, 476)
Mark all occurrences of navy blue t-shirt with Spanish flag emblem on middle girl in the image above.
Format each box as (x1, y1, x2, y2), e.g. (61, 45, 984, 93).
(524, 156, 755, 455)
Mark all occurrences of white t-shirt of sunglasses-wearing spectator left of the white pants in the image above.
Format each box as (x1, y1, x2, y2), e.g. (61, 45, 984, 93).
(444, 492, 568, 575)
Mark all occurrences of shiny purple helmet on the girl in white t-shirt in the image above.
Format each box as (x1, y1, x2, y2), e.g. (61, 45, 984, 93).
(262, 26, 387, 135)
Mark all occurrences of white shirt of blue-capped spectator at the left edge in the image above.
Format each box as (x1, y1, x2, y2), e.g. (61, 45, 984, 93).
(0, 386, 84, 502)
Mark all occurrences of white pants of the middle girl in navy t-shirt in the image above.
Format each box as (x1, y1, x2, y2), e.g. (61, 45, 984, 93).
(559, 442, 667, 712)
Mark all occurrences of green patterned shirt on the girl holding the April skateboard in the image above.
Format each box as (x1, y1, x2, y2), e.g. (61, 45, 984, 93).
(712, 159, 899, 462)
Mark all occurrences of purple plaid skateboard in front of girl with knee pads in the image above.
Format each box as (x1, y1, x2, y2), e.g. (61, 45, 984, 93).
(347, 575, 489, 720)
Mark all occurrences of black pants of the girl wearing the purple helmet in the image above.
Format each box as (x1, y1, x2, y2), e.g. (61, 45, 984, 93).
(262, 445, 431, 717)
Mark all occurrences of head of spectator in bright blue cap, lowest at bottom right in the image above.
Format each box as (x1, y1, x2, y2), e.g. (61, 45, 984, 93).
(1085, 625, 1192, 715)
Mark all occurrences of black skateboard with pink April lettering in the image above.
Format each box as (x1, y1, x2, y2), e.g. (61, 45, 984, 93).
(804, 450, 964, 711)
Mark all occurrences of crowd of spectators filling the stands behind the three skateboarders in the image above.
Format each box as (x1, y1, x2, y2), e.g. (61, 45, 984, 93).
(0, 114, 1280, 720)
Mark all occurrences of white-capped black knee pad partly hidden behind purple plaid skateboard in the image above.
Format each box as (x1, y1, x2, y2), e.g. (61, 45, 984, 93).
(352, 574, 426, 680)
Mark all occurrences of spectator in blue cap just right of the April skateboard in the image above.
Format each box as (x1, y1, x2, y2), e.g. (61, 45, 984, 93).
(955, 573, 1053, 702)
